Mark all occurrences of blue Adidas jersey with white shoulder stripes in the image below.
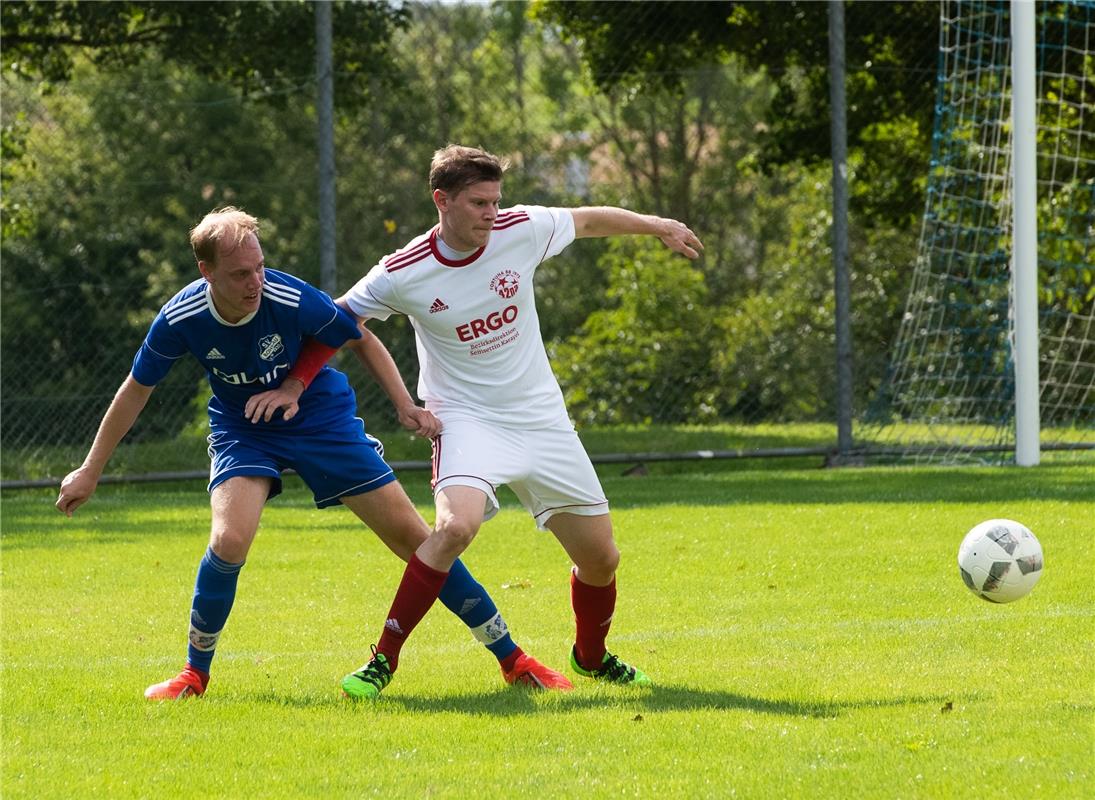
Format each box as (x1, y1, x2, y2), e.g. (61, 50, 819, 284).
(132, 269, 361, 430)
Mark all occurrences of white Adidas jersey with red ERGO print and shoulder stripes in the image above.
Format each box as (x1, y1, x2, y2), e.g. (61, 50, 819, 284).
(345, 206, 574, 428)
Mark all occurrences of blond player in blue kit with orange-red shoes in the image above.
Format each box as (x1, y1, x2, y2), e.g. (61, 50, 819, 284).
(56, 207, 572, 700)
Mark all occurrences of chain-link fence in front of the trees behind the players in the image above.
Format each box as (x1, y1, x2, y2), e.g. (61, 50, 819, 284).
(0, 2, 954, 484)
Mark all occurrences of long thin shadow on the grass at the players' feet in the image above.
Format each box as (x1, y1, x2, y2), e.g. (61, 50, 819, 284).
(240, 686, 972, 721)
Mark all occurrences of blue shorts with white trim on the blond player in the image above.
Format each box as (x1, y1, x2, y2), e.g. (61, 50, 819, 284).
(208, 417, 395, 508)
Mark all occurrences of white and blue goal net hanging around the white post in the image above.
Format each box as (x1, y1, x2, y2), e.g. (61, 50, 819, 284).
(861, 0, 1095, 463)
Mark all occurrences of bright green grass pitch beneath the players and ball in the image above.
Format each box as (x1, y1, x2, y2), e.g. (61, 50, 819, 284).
(0, 465, 1095, 799)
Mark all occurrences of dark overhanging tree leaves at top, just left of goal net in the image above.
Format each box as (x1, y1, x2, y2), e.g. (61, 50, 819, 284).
(535, 0, 938, 224)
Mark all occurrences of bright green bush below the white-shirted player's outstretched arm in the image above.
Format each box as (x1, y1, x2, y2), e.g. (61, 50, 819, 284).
(552, 240, 714, 424)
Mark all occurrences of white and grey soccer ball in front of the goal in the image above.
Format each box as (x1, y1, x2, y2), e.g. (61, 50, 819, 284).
(958, 520, 1041, 603)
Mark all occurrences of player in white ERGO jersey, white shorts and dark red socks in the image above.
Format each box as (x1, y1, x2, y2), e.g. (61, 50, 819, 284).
(253, 146, 703, 698)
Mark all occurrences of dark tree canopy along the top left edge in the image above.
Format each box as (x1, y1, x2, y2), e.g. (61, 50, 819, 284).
(0, 0, 408, 106)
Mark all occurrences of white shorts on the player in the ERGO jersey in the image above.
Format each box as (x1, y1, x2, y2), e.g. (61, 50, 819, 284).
(433, 418, 609, 531)
